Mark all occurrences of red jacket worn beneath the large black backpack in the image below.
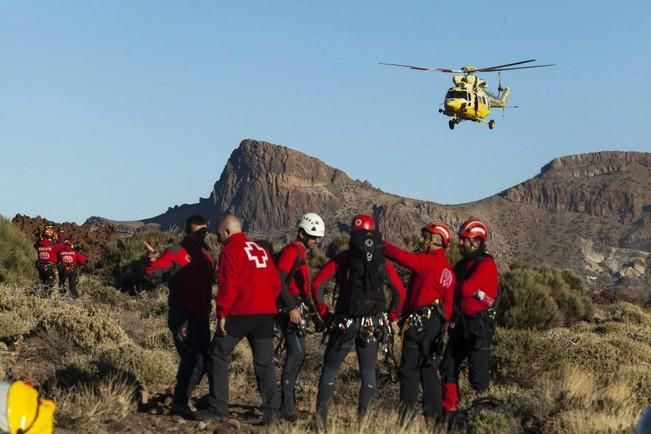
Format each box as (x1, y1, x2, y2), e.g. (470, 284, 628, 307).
(312, 250, 406, 321)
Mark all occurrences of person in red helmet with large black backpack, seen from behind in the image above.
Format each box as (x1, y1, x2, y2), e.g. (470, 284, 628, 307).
(312, 214, 405, 429)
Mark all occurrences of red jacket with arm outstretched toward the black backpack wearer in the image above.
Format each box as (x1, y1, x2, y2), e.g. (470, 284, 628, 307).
(384, 241, 455, 321)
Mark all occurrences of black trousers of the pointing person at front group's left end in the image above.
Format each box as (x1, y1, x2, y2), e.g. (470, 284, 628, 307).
(168, 306, 210, 405)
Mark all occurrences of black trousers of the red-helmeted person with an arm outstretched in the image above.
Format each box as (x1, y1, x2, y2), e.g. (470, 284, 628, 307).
(399, 314, 441, 423)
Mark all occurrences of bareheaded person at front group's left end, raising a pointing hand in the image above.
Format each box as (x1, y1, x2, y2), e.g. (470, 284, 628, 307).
(145, 215, 215, 419)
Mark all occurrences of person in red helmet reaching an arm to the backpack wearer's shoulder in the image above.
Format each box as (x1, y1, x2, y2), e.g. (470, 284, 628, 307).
(384, 221, 455, 425)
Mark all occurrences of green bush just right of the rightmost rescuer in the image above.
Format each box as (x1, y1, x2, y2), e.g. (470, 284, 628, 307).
(497, 264, 594, 330)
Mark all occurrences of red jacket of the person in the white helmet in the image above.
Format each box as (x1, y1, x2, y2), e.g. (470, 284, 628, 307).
(277, 241, 312, 309)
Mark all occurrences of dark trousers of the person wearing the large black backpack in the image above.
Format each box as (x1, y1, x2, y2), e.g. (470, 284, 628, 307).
(316, 319, 378, 426)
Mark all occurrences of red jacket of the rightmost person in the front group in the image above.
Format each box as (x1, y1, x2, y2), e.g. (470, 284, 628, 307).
(454, 256, 498, 316)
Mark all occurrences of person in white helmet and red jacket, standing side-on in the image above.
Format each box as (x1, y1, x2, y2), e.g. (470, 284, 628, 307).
(276, 213, 325, 422)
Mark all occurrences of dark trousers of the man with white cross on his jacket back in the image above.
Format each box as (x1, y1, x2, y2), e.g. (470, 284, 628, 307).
(207, 315, 280, 422)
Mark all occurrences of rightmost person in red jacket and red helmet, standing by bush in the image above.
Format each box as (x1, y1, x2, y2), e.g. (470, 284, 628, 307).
(441, 219, 498, 421)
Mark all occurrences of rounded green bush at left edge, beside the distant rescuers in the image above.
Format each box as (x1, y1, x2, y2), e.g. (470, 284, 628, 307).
(0, 216, 38, 284)
